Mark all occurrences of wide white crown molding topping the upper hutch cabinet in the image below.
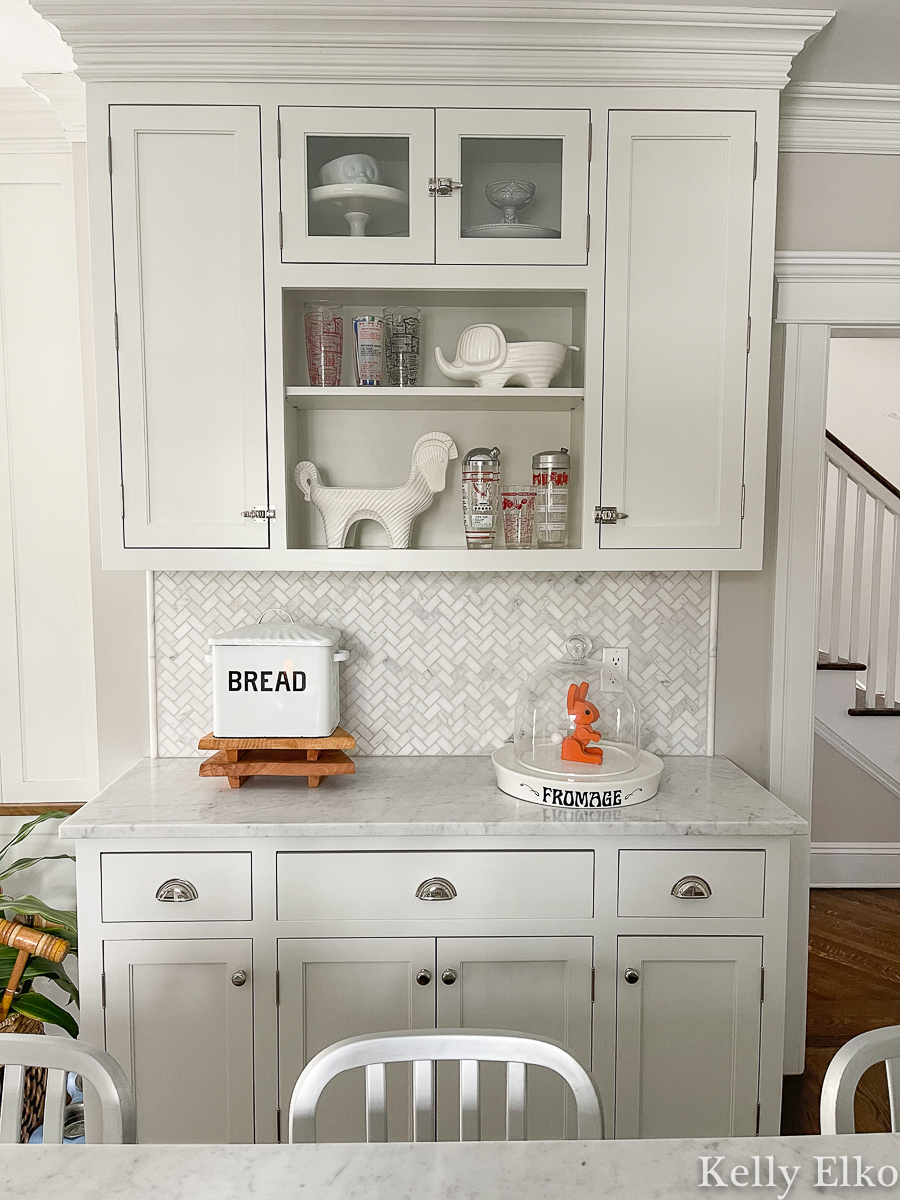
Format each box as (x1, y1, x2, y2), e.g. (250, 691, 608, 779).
(34, 0, 834, 88)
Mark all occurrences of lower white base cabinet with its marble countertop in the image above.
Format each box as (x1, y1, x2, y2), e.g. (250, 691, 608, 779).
(62, 758, 805, 1141)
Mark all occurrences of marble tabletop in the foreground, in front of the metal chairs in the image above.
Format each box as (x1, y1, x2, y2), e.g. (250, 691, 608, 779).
(0, 1134, 900, 1200)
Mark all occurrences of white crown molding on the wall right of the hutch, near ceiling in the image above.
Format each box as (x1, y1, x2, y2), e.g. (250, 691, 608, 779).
(779, 83, 900, 154)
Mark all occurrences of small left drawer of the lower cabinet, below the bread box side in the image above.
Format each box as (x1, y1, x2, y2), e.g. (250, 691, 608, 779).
(100, 853, 252, 920)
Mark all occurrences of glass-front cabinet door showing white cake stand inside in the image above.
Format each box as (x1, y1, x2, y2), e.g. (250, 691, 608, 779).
(278, 107, 434, 263)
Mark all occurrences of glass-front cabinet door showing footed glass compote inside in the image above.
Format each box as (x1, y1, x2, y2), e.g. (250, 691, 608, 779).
(434, 108, 590, 265)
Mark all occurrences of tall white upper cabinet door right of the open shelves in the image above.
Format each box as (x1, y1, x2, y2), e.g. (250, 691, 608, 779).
(600, 112, 756, 550)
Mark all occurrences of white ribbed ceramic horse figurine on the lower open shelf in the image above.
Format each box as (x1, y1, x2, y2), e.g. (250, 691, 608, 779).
(294, 433, 458, 550)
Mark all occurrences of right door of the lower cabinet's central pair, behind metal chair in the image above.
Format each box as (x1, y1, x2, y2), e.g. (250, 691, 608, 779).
(437, 937, 593, 1141)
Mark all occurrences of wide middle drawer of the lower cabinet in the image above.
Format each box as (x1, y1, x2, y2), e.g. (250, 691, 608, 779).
(277, 850, 594, 920)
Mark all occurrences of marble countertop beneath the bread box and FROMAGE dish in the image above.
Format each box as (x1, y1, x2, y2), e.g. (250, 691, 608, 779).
(60, 757, 806, 839)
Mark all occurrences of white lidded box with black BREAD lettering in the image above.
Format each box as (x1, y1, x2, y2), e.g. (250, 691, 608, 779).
(209, 610, 349, 738)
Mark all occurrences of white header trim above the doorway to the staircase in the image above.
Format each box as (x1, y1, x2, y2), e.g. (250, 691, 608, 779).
(775, 252, 900, 326)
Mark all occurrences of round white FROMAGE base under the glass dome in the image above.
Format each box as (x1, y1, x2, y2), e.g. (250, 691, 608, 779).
(491, 743, 662, 810)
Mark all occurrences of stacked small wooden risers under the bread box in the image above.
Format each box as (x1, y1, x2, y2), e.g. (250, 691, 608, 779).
(199, 725, 356, 787)
